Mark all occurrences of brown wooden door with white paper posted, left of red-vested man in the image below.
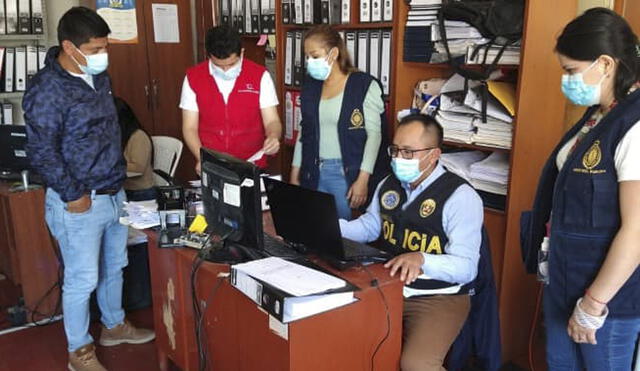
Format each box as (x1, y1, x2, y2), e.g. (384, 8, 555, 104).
(143, 0, 196, 180)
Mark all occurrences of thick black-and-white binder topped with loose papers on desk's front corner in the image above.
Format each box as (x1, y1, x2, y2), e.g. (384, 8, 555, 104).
(231, 257, 357, 323)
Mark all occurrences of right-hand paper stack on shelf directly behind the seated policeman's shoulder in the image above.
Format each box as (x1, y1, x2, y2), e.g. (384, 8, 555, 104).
(469, 152, 509, 195)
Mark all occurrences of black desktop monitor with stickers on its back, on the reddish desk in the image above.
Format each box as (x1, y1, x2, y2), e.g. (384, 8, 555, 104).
(200, 148, 263, 249)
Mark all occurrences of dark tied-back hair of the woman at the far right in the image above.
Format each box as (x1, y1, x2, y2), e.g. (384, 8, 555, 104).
(556, 8, 640, 101)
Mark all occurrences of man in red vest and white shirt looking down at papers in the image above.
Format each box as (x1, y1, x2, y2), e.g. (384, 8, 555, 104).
(180, 25, 282, 174)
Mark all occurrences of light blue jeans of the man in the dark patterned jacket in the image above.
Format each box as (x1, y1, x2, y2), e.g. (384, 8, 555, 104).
(45, 188, 127, 352)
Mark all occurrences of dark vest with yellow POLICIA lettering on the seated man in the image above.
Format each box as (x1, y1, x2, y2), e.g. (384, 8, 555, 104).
(377, 171, 468, 295)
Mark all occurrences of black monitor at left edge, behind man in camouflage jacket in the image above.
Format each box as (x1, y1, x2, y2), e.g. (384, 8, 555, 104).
(0, 125, 29, 172)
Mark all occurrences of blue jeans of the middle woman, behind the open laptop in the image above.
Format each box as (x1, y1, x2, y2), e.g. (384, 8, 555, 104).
(318, 159, 351, 220)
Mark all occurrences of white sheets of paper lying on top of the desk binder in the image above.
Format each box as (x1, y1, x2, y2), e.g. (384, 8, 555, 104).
(233, 257, 347, 296)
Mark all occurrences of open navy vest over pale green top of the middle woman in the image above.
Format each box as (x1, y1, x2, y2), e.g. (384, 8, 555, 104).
(300, 72, 390, 203)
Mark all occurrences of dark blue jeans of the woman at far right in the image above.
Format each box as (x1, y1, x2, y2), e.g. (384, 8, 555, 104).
(543, 289, 640, 371)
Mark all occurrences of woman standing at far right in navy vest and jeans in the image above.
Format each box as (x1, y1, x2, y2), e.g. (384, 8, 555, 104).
(523, 8, 640, 370)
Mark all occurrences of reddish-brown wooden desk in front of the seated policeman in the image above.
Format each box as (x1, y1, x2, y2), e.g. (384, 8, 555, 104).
(148, 214, 403, 371)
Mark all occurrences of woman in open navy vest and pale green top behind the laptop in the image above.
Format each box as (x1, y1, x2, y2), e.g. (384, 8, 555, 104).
(291, 25, 388, 220)
